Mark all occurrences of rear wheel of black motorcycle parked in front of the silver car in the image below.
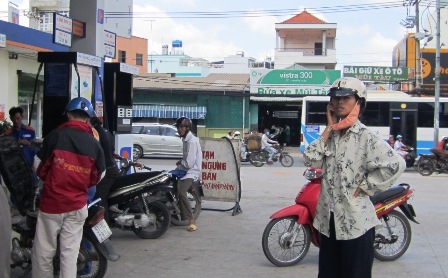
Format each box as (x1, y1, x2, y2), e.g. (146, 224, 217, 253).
(132, 201, 170, 239)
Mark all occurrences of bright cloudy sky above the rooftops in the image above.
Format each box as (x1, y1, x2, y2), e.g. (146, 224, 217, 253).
(0, 0, 440, 69)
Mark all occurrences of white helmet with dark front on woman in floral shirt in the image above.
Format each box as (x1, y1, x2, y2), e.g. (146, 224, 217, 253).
(327, 77, 367, 101)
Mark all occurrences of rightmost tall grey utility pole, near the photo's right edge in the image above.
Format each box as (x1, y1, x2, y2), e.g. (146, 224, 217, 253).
(434, 0, 440, 148)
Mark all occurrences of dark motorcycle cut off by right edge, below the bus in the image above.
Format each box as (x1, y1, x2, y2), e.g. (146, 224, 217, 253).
(417, 149, 448, 176)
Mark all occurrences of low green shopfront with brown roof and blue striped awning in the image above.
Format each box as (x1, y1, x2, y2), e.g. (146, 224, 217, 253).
(133, 74, 251, 138)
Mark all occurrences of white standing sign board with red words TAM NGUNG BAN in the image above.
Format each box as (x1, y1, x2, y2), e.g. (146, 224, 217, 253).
(201, 138, 241, 202)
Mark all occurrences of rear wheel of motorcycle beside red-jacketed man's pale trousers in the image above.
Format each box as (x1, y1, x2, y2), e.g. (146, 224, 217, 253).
(76, 232, 107, 278)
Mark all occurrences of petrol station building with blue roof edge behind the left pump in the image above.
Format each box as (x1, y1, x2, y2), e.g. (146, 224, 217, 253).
(0, 21, 68, 135)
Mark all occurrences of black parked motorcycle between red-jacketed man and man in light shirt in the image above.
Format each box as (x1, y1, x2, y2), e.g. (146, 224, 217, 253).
(107, 155, 170, 239)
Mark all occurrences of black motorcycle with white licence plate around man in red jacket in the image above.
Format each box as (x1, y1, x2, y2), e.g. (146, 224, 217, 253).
(0, 136, 120, 278)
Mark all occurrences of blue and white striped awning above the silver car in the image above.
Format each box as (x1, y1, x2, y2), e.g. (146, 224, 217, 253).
(132, 104, 207, 119)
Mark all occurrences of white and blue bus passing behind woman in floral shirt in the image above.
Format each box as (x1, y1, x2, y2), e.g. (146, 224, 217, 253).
(300, 90, 448, 155)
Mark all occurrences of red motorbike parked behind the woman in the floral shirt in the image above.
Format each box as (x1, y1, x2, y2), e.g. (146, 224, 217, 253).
(262, 168, 418, 266)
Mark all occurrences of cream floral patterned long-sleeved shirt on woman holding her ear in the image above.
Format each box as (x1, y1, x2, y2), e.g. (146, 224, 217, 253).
(303, 120, 406, 240)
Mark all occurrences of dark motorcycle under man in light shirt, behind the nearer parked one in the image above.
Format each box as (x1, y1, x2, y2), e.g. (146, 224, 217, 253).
(114, 156, 203, 226)
